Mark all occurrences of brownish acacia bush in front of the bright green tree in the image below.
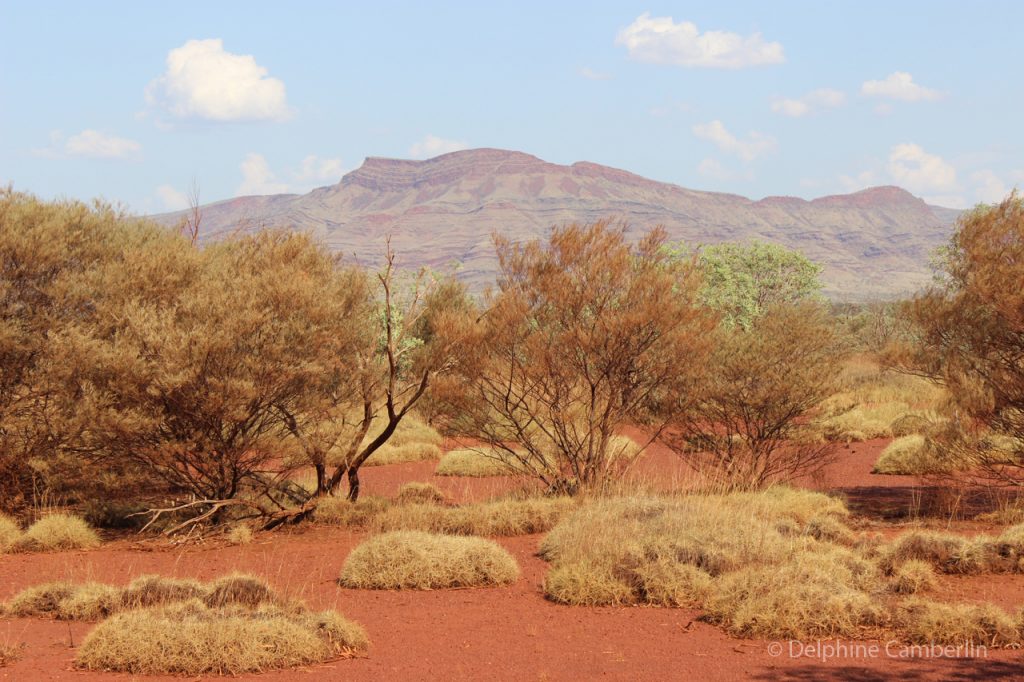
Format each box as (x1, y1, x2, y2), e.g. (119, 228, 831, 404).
(667, 302, 843, 487)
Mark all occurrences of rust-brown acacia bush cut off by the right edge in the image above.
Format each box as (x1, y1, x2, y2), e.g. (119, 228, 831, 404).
(887, 193, 1024, 485)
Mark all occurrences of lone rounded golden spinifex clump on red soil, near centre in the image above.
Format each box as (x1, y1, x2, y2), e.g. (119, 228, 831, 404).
(339, 530, 519, 590)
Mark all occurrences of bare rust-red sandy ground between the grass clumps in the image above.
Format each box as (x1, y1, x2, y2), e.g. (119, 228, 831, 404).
(0, 441, 1024, 682)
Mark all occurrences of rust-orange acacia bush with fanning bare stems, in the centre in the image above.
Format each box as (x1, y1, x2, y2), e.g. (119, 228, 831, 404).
(450, 222, 714, 494)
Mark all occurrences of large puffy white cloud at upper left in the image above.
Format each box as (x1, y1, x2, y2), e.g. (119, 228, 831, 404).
(145, 38, 291, 122)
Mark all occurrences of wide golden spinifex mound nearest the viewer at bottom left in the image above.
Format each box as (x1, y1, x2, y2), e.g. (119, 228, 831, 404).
(76, 602, 368, 675)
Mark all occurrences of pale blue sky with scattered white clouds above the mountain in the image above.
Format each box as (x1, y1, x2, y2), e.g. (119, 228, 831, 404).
(0, 0, 1024, 213)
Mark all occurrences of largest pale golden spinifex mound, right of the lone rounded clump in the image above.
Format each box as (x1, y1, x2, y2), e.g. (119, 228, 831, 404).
(541, 487, 849, 604)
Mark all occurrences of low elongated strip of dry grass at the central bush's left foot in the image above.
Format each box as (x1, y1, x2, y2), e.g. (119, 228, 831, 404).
(373, 498, 573, 537)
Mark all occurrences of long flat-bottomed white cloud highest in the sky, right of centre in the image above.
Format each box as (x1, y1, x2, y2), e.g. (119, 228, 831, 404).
(615, 12, 785, 69)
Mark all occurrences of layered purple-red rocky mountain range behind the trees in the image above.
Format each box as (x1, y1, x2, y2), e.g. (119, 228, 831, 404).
(158, 150, 957, 298)
